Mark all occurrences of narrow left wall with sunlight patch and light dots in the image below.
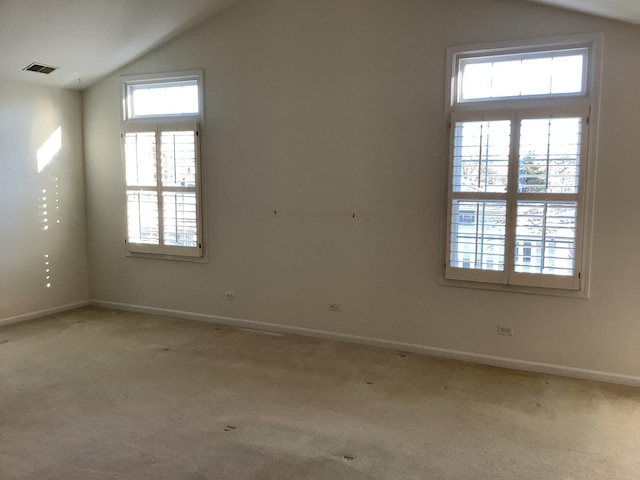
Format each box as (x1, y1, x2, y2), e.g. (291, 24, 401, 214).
(0, 82, 88, 321)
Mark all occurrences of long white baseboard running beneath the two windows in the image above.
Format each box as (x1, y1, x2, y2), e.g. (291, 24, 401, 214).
(91, 300, 640, 387)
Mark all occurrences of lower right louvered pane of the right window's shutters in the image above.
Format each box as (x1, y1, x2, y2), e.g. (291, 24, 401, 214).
(515, 201, 578, 276)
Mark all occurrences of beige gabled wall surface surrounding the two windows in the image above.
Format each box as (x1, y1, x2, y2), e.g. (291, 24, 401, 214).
(84, 0, 640, 376)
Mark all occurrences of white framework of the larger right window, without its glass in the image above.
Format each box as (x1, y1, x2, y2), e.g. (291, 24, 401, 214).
(439, 34, 602, 298)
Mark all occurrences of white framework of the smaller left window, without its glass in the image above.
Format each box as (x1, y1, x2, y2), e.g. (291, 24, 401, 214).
(120, 70, 205, 261)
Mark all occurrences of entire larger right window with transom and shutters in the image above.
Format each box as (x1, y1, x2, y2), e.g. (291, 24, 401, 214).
(444, 36, 598, 291)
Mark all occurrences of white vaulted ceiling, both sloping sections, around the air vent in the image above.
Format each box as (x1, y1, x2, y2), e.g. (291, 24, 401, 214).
(0, 0, 640, 89)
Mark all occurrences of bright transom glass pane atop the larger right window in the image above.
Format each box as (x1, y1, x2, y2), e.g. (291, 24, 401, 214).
(457, 48, 588, 102)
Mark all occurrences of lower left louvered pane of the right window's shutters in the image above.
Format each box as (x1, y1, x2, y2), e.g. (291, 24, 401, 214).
(449, 200, 506, 271)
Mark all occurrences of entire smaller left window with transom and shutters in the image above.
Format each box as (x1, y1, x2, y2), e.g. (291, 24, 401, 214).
(122, 72, 203, 257)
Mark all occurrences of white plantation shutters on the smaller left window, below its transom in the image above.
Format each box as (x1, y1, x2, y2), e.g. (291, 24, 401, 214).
(123, 123, 202, 257)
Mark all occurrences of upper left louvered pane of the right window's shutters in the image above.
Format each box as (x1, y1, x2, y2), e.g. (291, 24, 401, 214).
(453, 120, 511, 193)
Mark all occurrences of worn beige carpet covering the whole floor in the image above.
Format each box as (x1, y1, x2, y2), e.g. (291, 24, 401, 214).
(0, 309, 640, 480)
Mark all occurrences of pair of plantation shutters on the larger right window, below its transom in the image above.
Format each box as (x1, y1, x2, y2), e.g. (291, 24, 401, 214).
(445, 107, 588, 290)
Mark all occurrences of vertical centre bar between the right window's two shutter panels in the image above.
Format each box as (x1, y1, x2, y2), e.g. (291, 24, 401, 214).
(504, 111, 520, 283)
